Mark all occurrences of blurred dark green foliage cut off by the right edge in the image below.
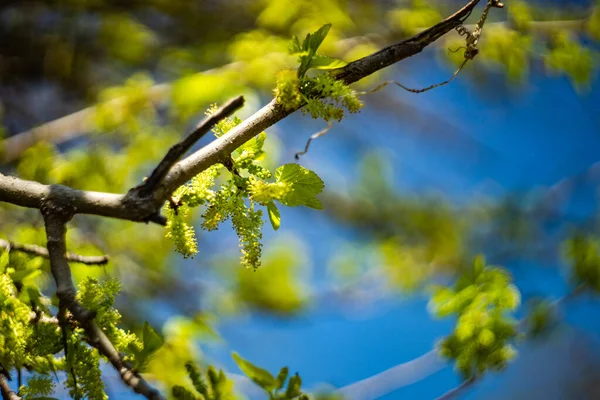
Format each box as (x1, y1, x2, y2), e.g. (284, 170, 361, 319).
(564, 235, 600, 292)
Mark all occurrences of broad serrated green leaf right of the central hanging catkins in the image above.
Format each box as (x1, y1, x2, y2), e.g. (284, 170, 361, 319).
(275, 164, 325, 210)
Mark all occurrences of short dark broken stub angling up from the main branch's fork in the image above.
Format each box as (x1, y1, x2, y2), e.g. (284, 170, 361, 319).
(134, 96, 244, 197)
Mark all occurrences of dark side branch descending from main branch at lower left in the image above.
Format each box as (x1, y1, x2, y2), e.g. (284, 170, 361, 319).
(42, 208, 163, 400)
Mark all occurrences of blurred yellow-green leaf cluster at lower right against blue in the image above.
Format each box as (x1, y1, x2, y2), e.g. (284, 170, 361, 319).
(430, 256, 520, 379)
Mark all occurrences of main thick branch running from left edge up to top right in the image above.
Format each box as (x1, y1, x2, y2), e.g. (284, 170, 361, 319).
(0, 0, 492, 220)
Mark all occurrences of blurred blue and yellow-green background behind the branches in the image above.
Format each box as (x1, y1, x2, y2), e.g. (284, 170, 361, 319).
(0, 0, 600, 399)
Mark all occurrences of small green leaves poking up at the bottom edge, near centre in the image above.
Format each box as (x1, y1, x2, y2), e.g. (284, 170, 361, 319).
(232, 353, 308, 400)
